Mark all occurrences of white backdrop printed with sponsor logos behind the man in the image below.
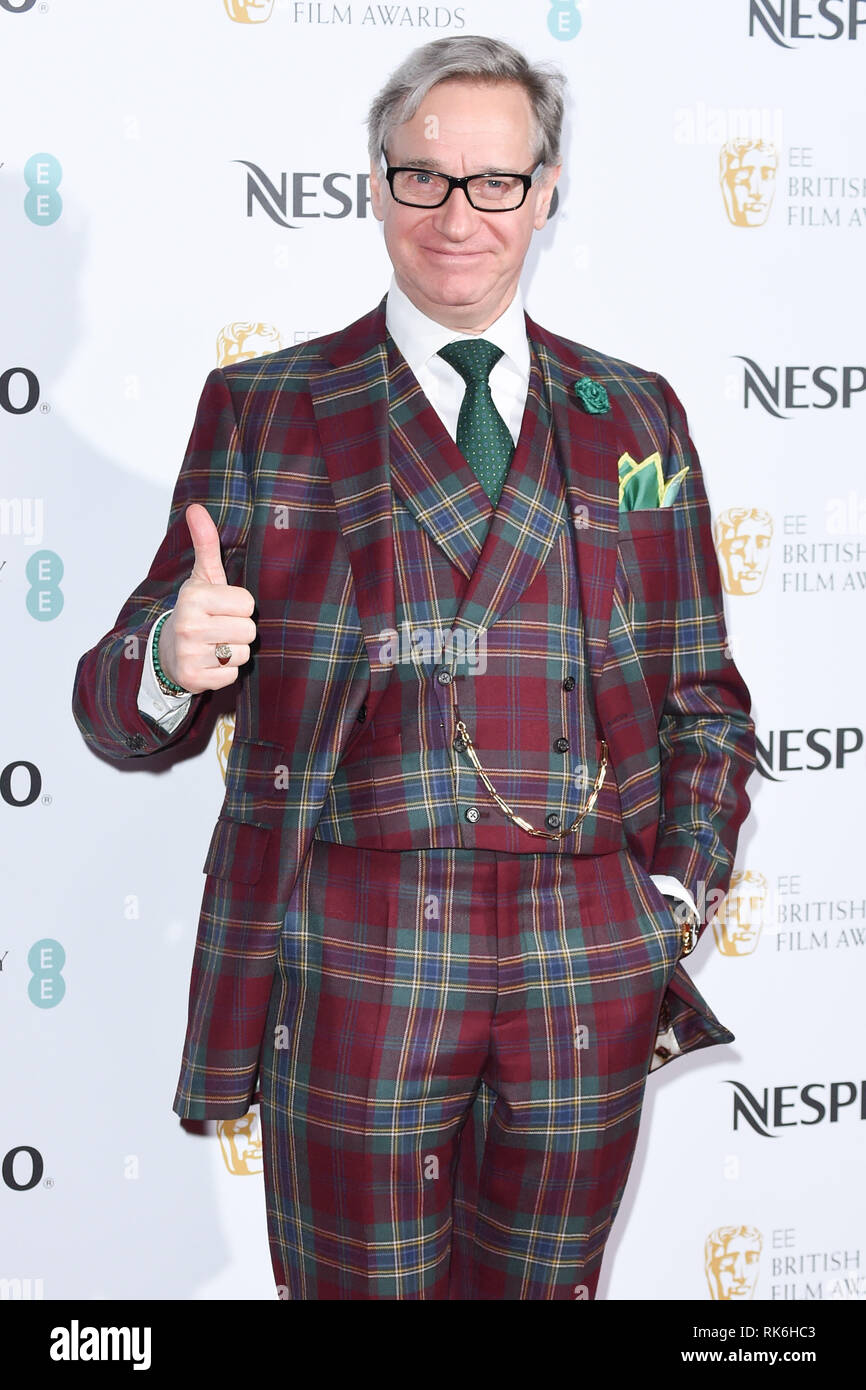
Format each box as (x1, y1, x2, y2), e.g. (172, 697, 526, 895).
(0, 0, 866, 1300)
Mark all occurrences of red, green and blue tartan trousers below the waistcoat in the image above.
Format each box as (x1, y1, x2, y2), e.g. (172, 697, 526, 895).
(260, 841, 680, 1300)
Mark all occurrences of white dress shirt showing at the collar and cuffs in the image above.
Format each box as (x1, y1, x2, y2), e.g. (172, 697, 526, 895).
(138, 275, 696, 1000)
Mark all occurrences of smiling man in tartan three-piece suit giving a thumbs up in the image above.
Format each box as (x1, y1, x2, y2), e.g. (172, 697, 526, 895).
(74, 38, 753, 1300)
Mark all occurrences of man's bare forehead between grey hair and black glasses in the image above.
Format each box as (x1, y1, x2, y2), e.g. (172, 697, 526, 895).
(388, 81, 535, 168)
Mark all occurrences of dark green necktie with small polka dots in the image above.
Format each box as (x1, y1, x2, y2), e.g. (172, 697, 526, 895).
(439, 338, 514, 506)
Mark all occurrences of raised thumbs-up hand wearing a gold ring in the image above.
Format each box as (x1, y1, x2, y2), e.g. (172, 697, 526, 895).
(160, 502, 256, 695)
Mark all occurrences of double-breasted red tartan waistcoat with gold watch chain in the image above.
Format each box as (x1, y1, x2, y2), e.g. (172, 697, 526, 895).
(314, 338, 627, 855)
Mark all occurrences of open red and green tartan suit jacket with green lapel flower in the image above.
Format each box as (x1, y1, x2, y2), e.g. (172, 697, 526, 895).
(72, 299, 755, 1119)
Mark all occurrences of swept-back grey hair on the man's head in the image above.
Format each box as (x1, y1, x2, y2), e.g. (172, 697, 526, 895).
(367, 35, 566, 167)
